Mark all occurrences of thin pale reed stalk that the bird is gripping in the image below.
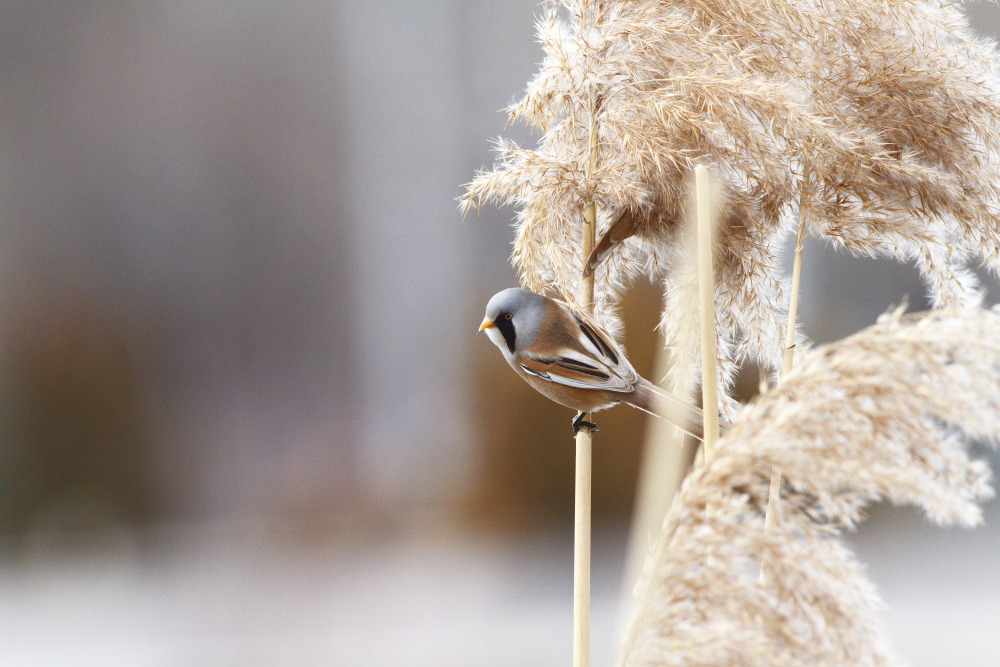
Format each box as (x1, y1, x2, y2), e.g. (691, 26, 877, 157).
(573, 90, 597, 667)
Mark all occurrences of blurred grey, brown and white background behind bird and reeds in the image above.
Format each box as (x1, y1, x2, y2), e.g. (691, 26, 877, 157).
(0, 0, 1000, 666)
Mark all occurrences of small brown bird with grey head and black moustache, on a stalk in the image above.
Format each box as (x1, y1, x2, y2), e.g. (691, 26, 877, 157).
(479, 287, 720, 439)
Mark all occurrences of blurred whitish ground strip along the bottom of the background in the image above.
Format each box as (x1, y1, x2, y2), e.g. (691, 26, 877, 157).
(0, 508, 1000, 667)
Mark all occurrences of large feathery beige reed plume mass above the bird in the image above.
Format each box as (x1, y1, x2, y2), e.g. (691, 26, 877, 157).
(463, 0, 1000, 413)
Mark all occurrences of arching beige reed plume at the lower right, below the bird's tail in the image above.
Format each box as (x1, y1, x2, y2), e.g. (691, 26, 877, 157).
(620, 309, 1000, 666)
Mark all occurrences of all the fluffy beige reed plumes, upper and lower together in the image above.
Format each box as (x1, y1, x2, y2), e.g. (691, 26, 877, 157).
(463, 0, 1000, 665)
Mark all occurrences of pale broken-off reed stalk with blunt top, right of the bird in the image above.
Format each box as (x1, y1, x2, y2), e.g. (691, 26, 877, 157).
(694, 165, 719, 462)
